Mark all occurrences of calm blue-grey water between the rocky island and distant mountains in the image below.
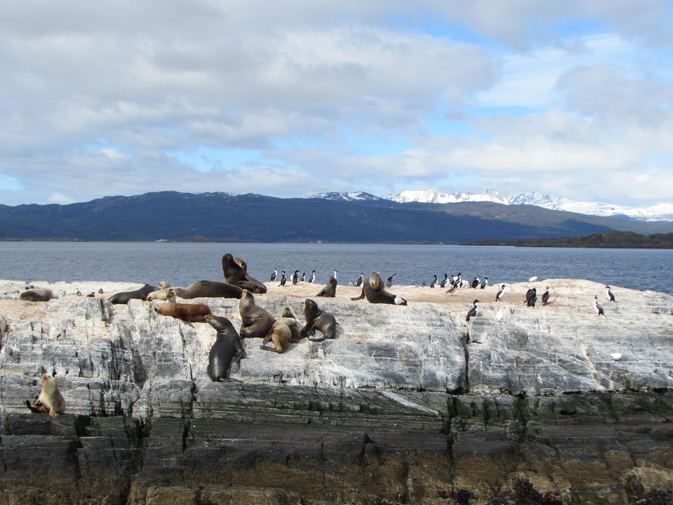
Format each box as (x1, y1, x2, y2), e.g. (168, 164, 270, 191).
(0, 242, 673, 294)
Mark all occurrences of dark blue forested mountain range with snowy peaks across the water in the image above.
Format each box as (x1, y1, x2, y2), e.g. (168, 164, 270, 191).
(0, 191, 673, 244)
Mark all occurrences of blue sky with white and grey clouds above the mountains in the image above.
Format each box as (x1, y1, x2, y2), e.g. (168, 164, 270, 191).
(0, 0, 673, 207)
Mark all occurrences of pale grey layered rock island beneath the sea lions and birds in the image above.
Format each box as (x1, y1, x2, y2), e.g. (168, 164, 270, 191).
(0, 279, 673, 505)
